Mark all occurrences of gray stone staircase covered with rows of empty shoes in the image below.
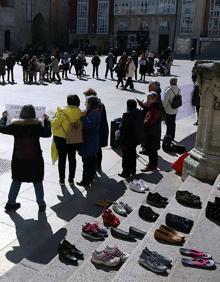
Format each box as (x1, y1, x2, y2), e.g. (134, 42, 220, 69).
(0, 172, 220, 282)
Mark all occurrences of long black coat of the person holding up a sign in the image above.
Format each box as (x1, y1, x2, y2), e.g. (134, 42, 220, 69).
(0, 118, 51, 182)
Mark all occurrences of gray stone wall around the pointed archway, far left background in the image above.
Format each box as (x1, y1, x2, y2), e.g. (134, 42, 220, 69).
(0, 0, 68, 52)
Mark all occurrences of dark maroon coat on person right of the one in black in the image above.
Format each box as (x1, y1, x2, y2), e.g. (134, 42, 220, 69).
(144, 102, 161, 152)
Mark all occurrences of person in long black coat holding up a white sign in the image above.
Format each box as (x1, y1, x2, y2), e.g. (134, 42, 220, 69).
(0, 105, 51, 212)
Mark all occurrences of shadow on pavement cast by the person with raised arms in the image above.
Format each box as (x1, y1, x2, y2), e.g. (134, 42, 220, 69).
(6, 212, 67, 264)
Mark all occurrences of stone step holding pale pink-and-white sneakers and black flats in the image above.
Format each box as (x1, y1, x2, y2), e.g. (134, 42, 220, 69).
(67, 173, 182, 282)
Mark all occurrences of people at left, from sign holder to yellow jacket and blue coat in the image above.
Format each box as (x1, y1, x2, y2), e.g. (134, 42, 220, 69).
(0, 89, 109, 211)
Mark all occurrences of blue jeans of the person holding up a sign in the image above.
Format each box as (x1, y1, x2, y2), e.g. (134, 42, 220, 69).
(8, 180, 45, 206)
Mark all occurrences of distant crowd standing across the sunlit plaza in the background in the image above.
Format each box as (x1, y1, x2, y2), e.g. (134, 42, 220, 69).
(0, 47, 173, 85)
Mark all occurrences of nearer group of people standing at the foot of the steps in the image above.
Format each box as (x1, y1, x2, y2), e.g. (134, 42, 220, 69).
(0, 69, 201, 211)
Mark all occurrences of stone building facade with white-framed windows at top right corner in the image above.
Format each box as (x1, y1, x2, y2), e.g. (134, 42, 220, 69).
(175, 0, 220, 57)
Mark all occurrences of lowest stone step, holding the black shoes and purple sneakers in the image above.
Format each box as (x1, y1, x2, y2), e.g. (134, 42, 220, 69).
(0, 172, 172, 282)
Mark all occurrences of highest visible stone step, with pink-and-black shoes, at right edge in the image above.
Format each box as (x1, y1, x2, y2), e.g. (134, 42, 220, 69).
(169, 175, 220, 282)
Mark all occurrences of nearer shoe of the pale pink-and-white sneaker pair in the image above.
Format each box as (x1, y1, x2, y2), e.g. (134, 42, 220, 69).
(91, 250, 121, 267)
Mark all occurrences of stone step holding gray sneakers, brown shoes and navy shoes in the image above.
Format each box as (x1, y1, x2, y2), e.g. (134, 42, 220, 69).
(112, 176, 213, 282)
